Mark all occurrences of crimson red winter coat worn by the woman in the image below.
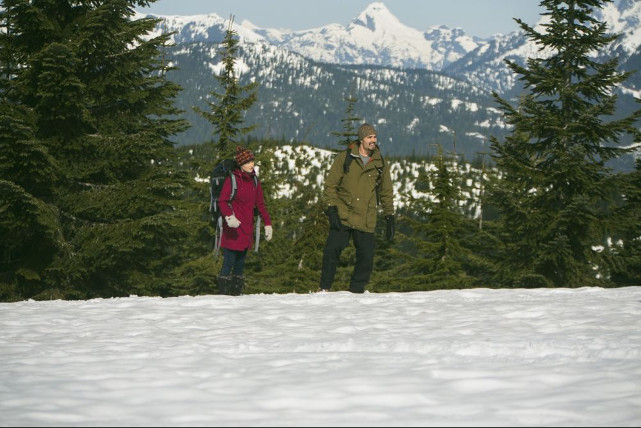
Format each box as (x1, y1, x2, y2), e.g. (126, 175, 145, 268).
(218, 169, 272, 251)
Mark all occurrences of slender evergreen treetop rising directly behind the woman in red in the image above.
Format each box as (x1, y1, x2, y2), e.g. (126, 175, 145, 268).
(194, 16, 258, 157)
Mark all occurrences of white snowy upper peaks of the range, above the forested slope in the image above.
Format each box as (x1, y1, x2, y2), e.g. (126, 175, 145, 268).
(144, 0, 641, 93)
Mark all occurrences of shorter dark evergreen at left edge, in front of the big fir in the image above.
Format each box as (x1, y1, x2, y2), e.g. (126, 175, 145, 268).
(0, 104, 64, 301)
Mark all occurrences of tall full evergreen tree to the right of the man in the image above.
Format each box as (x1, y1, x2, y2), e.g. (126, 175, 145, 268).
(492, 0, 641, 287)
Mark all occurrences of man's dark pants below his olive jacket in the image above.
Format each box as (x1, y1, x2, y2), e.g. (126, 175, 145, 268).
(320, 226, 374, 293)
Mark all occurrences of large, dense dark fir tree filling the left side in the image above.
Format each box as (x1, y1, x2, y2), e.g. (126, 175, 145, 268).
(0, 0, 190, 298)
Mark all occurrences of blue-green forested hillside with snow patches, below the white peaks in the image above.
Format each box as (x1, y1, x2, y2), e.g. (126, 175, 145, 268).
(162, 42, 507, 160)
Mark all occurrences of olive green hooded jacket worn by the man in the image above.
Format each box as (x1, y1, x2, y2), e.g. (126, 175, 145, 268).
(323, 144, 394, 232)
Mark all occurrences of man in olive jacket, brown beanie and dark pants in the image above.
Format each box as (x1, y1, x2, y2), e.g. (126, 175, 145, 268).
(320, 123, 395, 293)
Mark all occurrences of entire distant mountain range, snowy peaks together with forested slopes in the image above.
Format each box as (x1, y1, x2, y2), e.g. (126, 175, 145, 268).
(137, 0, 641, 166)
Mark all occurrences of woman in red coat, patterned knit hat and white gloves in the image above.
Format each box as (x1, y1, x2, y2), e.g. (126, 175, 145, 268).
(218, 146, 272, 296)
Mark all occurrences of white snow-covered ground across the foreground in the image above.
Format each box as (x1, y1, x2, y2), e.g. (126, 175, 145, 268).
(0, 287, 641, 427)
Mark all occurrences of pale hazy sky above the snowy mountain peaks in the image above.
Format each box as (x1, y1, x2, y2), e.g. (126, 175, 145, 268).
(138, 0, 544, 37)
